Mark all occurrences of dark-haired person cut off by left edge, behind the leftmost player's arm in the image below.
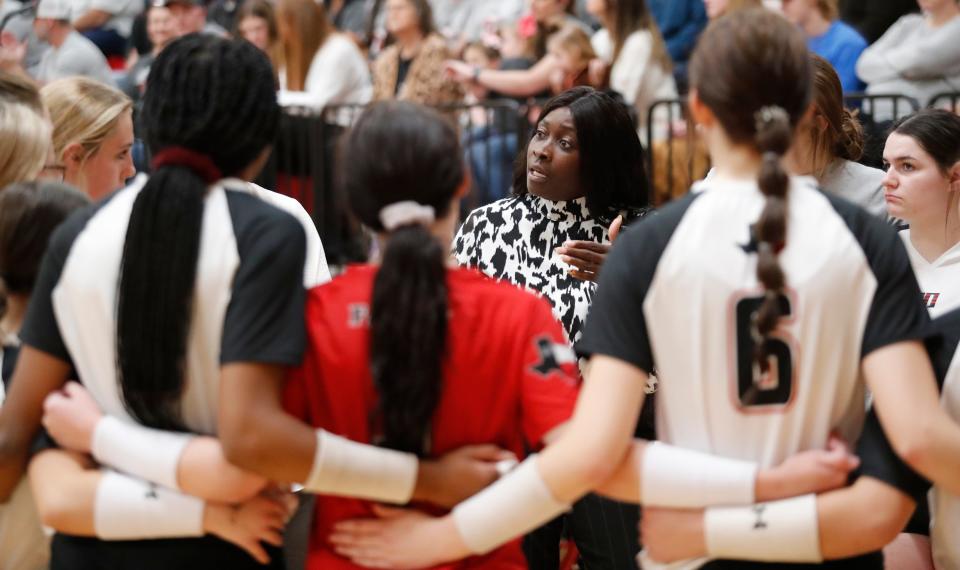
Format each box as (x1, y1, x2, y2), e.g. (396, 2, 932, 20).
(0, 182, 90, 570)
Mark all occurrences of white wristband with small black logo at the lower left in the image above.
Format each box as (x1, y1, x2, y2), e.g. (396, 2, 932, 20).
(93, 469, 204, 540)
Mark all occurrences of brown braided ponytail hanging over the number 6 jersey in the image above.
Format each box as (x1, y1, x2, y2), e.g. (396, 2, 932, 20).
(754, 106, 793, 372)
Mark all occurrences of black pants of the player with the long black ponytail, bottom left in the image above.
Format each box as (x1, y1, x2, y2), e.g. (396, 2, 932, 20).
(50, 534, 284, 570)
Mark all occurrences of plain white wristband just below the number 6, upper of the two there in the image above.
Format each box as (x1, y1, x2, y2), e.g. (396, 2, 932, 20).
(640, 442, 757, 508)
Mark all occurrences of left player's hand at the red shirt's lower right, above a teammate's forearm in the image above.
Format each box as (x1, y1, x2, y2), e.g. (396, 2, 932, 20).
(414, 444, 516, 508)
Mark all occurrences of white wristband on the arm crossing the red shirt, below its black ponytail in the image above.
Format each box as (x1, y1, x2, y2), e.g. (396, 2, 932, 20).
(304, 429, 419, 505)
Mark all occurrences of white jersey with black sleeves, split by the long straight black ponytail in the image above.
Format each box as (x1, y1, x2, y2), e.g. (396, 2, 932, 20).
(20, 177, 305, 434)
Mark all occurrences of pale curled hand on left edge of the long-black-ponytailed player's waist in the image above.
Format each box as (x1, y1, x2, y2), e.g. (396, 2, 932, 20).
(43, 381, 103, 453)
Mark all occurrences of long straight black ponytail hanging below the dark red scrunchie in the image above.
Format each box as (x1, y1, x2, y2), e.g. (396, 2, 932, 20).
(117, 166, 207, 431)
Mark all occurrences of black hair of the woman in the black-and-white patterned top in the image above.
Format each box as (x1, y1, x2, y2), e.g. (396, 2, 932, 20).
(513, 87, 650, 224)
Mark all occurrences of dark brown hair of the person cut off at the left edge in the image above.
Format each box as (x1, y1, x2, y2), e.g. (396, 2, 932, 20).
(0, 182, 90, 295)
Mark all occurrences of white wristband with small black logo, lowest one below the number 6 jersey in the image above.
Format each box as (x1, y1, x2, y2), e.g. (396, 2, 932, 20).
(704, 495, 823, 562)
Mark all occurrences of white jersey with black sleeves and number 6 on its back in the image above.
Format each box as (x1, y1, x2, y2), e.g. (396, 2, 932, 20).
(577, 177, 929, 563)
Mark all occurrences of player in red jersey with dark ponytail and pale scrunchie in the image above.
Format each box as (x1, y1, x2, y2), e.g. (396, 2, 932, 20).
(286, 103, 579, 570)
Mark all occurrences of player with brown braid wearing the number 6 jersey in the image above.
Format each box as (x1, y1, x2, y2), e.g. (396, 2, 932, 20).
(324, 9, 960, 569)
